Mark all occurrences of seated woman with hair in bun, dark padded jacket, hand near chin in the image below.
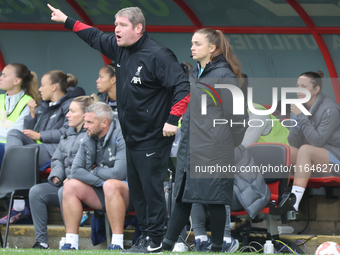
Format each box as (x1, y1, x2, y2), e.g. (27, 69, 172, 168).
(0, 70, 85, 224)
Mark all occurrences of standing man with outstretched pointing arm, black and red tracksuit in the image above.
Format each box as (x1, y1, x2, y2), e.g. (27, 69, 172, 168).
(48, 5, 190, 253)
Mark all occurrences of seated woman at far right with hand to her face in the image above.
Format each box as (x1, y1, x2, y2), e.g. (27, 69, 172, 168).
(288, 71, 340, 211)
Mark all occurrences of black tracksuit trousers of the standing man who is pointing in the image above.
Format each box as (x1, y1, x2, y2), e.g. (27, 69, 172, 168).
(126, 144, 172, 244)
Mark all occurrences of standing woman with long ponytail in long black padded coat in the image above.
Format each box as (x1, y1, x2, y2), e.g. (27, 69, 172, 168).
(162, 28, 248, 252)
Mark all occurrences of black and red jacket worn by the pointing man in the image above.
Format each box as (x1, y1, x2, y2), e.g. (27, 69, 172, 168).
(65, 18, 190, 150)
